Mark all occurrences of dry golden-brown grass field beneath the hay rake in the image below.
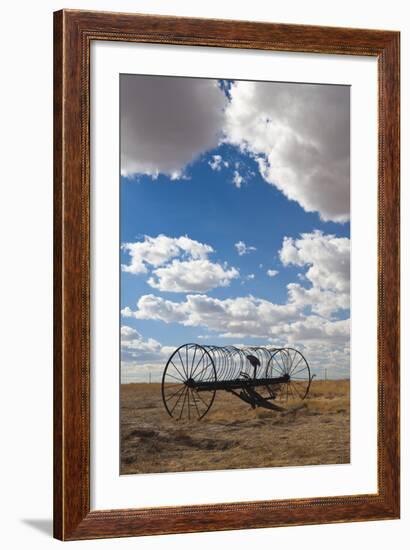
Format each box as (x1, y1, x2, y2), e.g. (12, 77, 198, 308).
(121, 380, 350, 474)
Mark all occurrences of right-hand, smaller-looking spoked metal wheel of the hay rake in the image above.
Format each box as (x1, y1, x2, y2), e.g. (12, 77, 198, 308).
(266, 348, 312, 407)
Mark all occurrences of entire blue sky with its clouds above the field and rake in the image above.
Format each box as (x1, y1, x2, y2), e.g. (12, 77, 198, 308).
(120, 76, 350, 380)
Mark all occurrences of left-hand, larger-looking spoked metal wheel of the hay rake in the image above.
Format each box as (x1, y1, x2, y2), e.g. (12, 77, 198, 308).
(162, 344, 216, 420)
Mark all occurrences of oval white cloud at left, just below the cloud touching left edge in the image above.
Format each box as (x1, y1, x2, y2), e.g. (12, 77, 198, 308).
(147, 260, 239, 292)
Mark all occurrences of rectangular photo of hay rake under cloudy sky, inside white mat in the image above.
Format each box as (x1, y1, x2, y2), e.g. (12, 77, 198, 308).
(119, 74, 350, 474)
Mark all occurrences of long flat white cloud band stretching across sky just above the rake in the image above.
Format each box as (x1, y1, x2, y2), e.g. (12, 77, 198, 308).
(122, 294, 350, 365)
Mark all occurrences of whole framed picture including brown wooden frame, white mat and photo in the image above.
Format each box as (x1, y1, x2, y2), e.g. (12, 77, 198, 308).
(53, 10, 400, 540)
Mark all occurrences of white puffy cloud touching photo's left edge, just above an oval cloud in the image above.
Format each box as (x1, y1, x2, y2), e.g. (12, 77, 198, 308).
(121, 235, 213, 274)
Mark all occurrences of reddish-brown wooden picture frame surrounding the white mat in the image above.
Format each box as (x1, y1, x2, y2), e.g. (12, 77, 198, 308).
(54, 10, 400, 540)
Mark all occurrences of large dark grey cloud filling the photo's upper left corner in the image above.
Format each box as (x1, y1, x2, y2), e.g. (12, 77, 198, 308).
(120, 75, 228, 177)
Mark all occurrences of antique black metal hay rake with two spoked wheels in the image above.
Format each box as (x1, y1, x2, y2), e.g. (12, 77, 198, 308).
(161, 344, 313, 420)
